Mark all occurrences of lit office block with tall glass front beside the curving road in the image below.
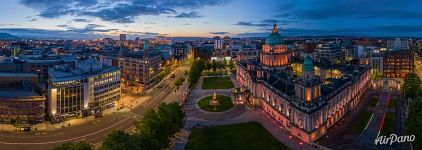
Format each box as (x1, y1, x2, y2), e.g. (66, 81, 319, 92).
(47, 60, 121, 121)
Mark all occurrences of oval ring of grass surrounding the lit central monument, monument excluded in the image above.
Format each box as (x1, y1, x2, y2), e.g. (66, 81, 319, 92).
(198, 95, 233, 112)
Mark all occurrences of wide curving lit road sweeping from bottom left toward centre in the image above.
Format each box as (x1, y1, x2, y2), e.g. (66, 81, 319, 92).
(0, 67, 187, 150)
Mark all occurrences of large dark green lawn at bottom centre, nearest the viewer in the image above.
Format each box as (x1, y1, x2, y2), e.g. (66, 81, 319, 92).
(185, 122, 289, 150)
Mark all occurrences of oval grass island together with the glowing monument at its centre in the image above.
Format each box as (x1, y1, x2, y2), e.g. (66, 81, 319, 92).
(197, 93, 234, 112)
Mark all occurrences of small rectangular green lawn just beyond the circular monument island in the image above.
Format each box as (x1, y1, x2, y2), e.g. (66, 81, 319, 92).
(202, 77, 234, 89)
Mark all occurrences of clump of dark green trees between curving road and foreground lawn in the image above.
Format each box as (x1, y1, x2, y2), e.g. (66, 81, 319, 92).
(102, 103, 185, 150)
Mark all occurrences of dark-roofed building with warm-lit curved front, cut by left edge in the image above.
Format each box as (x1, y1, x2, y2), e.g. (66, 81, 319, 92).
(0, 76, 46, 124)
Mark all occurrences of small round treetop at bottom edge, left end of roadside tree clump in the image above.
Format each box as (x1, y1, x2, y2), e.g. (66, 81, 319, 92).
(102, 130, 139, 150)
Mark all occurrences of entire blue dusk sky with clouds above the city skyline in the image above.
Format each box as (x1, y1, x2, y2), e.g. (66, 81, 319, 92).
(0, 0, 422, 38)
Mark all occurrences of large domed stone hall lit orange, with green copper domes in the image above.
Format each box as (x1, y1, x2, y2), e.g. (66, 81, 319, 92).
(236, 26, 370, 142)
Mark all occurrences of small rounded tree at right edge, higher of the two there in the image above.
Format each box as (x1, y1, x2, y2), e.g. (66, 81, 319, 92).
(403, 73, 422, 98)
